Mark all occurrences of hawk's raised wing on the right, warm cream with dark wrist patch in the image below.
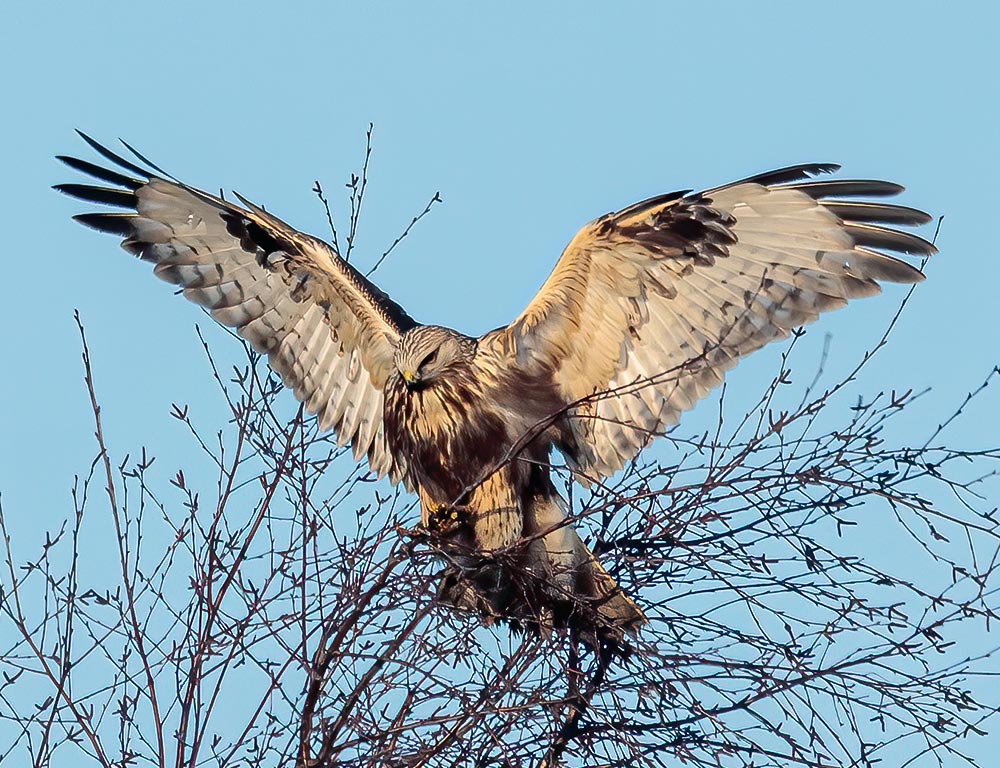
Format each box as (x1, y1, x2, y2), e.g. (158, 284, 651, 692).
(493, 165, 935, 482)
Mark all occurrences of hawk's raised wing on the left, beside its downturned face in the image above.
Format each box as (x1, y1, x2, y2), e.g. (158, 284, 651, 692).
(56, 134, 415, 482)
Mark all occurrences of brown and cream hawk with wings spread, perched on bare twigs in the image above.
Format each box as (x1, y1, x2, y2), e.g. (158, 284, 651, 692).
(57, 134, 935, 644)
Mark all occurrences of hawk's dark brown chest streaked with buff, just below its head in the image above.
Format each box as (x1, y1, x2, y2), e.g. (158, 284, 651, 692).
(384, 367, 512, 504)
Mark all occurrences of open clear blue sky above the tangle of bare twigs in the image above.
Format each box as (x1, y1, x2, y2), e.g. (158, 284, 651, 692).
(0, 2, 1000, 760)
